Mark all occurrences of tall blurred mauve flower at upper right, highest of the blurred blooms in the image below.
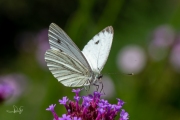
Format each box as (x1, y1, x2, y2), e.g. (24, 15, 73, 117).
(148, 25, 175, 61)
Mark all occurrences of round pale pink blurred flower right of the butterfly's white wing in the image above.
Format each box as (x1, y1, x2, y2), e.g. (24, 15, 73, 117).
(117, 45, 146, 74)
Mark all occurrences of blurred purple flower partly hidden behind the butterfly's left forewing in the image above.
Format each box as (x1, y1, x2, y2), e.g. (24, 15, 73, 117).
(36, 29, 50, 68)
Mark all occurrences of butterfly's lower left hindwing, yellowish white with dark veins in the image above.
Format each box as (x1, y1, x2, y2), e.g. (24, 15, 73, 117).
(45, 49, 90, 87)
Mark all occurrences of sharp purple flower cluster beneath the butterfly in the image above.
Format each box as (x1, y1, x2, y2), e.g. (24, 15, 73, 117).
(46, 89, 129, 120)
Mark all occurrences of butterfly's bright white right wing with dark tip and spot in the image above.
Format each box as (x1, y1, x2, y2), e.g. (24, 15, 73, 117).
(82, 26, 114, 73)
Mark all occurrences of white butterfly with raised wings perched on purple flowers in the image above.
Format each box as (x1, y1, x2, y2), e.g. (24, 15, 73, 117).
(45, 23, 113, 87)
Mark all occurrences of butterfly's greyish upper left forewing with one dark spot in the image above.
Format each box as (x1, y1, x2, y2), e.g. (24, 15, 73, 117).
(48, 23, 92, 72)
